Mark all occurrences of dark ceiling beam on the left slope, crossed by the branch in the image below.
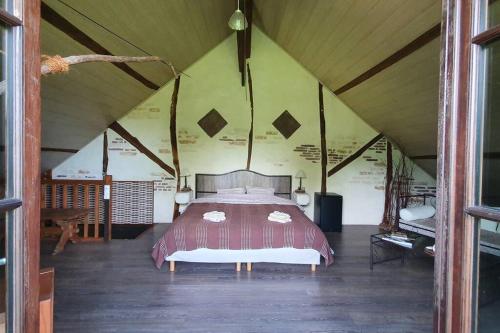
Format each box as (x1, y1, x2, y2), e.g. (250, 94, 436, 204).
(41, 2, 160, 90)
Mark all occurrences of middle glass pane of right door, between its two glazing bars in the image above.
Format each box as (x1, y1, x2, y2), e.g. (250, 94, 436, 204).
(481, 39, 500, 207)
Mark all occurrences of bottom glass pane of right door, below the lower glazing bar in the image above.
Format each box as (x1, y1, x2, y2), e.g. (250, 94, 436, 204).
(478, 220, 500, 333)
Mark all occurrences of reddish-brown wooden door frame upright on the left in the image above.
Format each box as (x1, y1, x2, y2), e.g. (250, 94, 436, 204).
(22, 0, 41, 332)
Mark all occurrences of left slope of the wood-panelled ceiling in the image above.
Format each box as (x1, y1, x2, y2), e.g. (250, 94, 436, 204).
(41, 0, 234, 169)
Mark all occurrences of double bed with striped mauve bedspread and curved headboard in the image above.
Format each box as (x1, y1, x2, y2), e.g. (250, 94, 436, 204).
(152, 170, 333, 271)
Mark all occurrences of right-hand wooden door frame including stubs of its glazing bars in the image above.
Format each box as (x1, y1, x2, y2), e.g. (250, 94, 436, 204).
(434, 0, 500, 333)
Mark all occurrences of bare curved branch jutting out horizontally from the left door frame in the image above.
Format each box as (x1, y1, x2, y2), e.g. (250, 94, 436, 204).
(41, 54, 179, 78)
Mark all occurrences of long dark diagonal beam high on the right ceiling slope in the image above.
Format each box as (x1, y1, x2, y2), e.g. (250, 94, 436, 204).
(333, 23, 441, 95)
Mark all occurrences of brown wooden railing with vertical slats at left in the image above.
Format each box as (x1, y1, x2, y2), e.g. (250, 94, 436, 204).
(41, 176, 112, 240)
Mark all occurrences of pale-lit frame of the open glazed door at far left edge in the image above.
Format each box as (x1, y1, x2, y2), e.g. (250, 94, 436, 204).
(0, 0, 25, 332)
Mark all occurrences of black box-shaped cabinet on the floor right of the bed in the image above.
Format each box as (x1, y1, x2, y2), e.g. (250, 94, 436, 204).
(314, 192, 342, 232)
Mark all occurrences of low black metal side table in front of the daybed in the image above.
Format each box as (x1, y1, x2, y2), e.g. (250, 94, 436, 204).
(370, 232, 425, 270)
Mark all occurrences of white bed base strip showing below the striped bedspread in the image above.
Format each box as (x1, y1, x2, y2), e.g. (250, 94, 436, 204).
(165, 248, 321, 265)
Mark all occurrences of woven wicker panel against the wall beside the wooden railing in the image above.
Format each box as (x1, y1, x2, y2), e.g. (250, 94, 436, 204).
(111, 181, 154, 224)
